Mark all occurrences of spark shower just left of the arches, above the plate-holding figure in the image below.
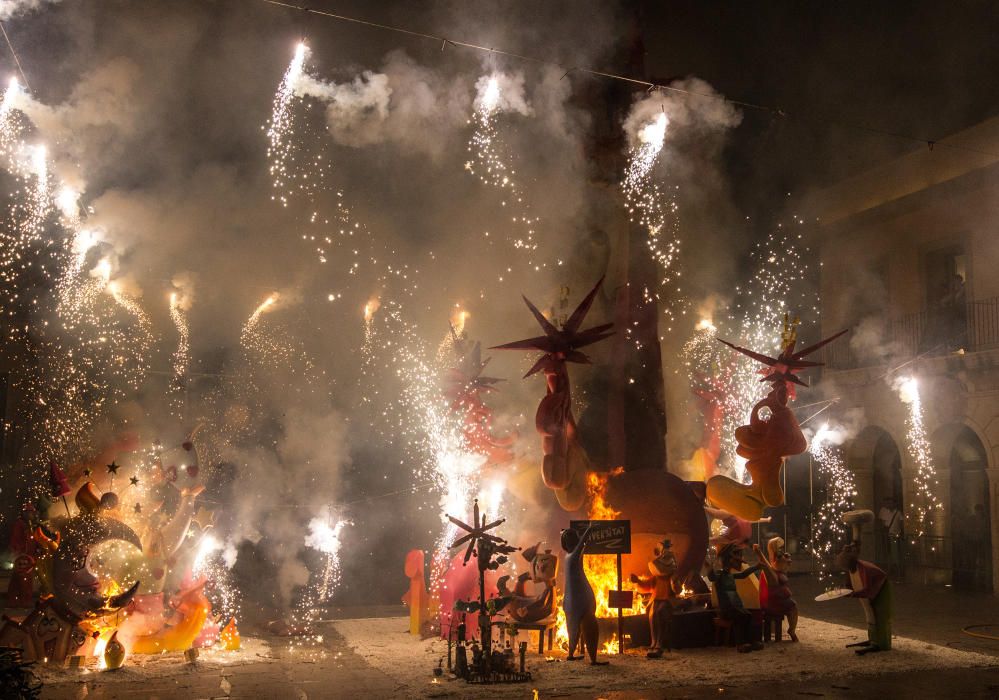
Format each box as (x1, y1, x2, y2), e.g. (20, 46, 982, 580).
(808, 423, 857, 582)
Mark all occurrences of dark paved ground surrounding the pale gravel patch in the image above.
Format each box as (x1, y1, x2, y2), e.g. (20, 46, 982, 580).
(13, 576, 999, 700)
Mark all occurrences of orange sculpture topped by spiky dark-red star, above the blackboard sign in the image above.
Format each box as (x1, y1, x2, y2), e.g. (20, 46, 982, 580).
(492, 277, 614, 511)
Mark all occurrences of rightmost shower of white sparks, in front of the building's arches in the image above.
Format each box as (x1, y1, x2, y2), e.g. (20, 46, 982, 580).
(893, 377, 943, 544)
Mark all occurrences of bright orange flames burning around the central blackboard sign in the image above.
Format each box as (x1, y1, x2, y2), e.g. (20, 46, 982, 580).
(555, 467, 641, 654)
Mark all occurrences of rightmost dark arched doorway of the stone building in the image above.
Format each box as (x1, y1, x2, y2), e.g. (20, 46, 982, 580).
(947, 425, 992, 591)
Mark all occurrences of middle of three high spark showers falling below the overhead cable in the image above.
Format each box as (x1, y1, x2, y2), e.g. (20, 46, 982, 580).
(465, 76, 548, 281)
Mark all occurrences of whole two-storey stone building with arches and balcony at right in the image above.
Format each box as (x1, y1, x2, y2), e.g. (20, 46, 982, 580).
(804, 117, 999, 591)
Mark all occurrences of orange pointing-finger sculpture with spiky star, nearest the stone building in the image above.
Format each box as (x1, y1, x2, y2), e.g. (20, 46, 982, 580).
(707, 315, 846, 520)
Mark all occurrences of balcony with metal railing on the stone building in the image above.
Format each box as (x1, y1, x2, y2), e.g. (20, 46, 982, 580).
(824, 297, 999, 369)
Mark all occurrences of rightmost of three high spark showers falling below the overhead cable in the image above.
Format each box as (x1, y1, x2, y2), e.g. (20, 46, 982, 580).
(621, 113, 683, 322)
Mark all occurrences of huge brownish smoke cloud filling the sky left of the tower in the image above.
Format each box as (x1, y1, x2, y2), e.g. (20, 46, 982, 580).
(0, 2, 632, 606)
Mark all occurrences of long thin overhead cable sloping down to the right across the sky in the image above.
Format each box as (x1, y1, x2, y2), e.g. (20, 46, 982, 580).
(252, 0, 999, 159)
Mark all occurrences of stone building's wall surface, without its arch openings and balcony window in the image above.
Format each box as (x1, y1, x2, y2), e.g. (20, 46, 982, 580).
(809, 119, 999, 590)
